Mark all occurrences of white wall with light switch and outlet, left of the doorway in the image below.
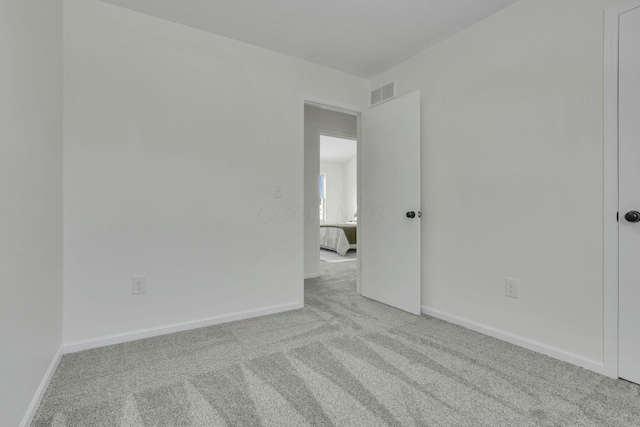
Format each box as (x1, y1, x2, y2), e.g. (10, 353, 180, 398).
(64, 0, 368, 344)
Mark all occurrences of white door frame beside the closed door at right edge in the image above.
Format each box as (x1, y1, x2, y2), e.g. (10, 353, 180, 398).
(603, 0, 640, 378)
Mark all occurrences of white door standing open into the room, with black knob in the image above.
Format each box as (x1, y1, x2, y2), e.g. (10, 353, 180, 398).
(358, 92, 421, 314)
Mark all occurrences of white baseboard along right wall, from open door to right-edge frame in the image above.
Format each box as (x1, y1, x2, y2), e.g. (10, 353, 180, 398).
(422, 306, 604, 375)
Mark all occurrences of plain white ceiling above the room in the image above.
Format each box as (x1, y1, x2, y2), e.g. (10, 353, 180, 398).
(103, 0, 517, 78)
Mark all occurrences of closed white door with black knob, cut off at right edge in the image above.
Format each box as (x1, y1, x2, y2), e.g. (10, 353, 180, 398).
(618, 4, 640, 383)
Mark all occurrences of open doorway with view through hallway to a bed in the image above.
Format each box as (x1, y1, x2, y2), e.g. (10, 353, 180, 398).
(304, 104, 358, 290)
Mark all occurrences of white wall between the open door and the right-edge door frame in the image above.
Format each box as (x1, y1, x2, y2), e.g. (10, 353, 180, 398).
(372, 0, 620, 361)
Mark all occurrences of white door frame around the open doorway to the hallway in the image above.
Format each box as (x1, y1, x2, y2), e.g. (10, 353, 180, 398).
(298, 94, 368, 306)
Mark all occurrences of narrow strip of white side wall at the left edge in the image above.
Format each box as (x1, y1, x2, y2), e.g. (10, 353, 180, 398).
(0, 0, 62, 426)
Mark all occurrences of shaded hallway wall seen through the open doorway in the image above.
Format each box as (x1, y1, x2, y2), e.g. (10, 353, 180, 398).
(304, 107, 358, 276)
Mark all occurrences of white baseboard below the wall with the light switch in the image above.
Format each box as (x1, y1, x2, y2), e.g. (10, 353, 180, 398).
(64, 301, 304, 353)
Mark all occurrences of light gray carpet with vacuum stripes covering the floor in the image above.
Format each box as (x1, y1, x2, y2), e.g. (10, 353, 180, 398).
(33, 263, 640, 427)
